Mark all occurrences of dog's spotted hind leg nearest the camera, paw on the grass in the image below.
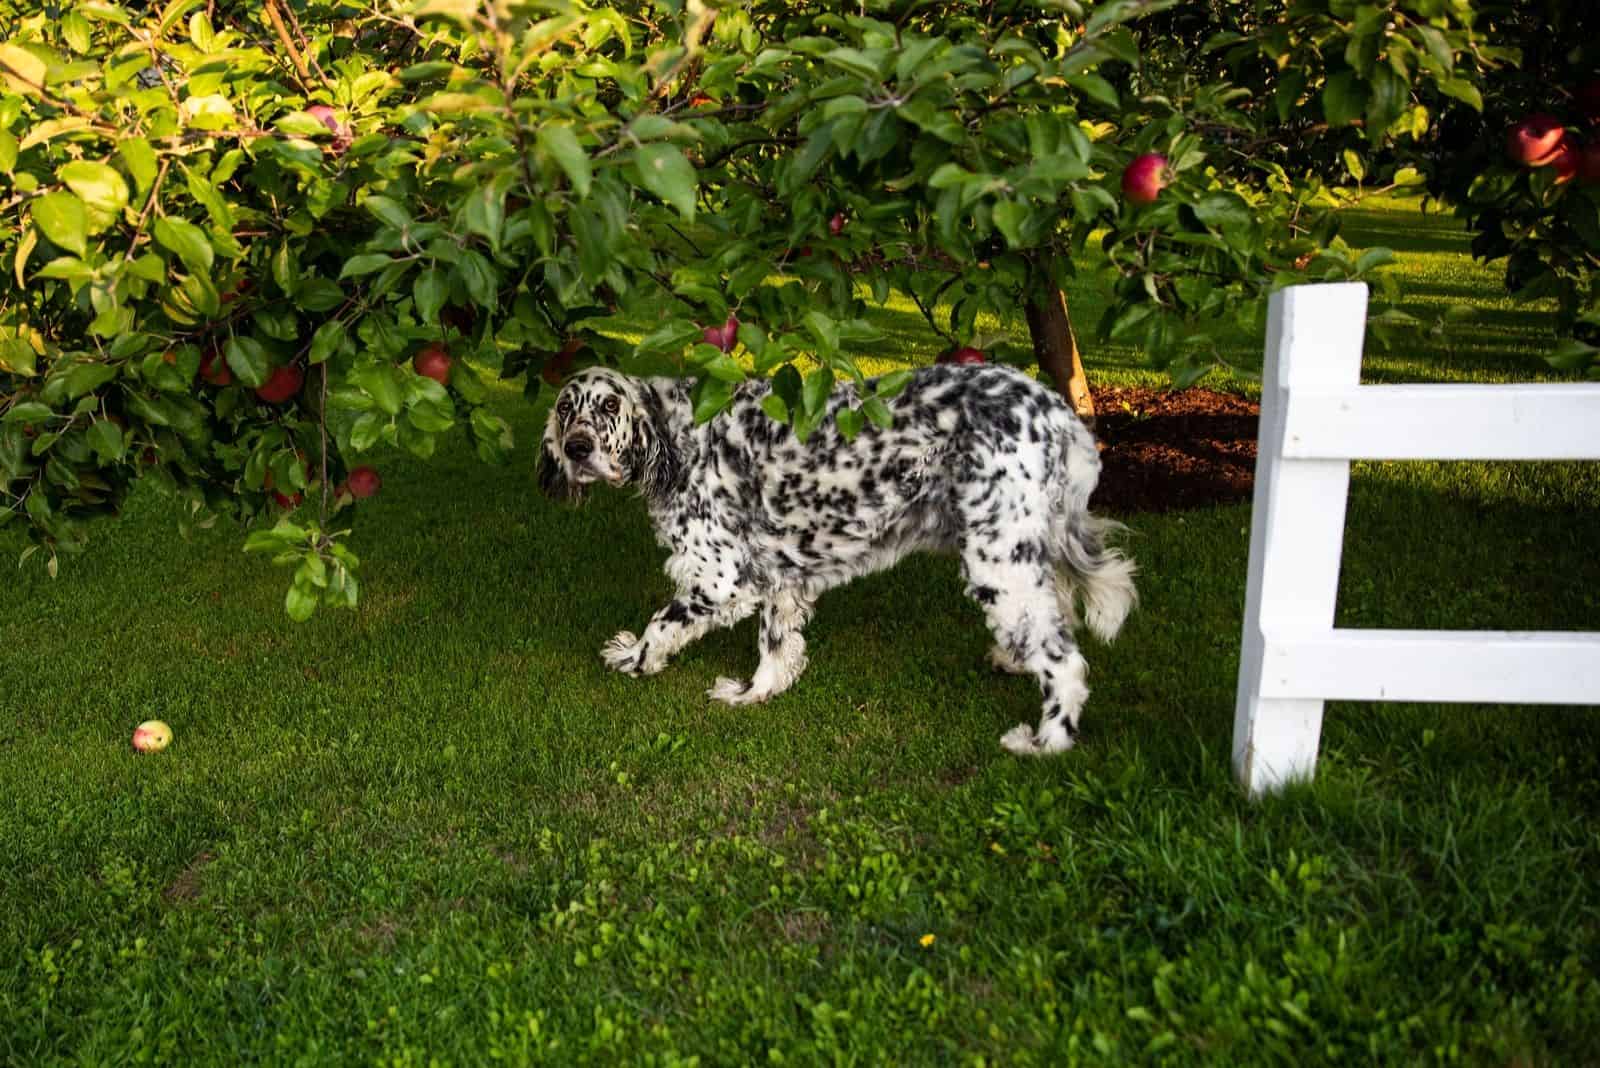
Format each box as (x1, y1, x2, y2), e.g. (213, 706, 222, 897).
(962, 540, 1090, 756)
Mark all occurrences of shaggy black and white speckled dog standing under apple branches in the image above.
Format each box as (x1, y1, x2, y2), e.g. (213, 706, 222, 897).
(539, 365, 1136, 753)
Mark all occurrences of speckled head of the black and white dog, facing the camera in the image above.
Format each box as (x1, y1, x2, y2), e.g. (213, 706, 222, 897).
(539, 368, 670, 497)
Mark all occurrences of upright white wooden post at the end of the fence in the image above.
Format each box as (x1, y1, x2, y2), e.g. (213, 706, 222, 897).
(1234, 283, 1366, 796)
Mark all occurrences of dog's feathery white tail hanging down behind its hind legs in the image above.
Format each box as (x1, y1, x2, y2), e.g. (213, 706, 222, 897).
(1050, 427, 1139, 641)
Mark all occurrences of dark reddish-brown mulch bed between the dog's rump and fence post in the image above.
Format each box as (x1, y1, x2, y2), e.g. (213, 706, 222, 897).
(1091, 387, 1261, 513)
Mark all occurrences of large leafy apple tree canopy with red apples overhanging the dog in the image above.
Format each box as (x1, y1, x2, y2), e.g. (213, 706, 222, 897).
(0, 0, 1482, 619)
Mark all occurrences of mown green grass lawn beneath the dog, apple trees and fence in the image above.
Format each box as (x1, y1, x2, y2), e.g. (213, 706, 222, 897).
(0, 203, 1600, 1065)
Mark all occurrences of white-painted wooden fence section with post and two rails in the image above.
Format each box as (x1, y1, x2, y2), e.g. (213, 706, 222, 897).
(1234, 283, 1600, 795)
